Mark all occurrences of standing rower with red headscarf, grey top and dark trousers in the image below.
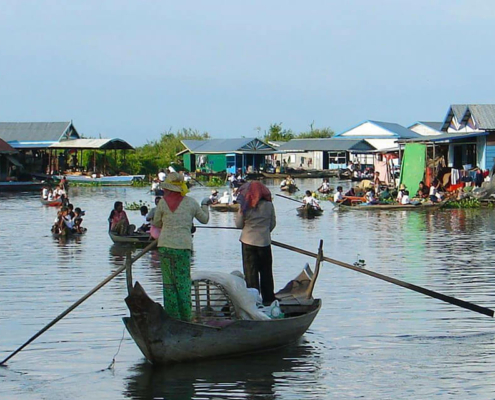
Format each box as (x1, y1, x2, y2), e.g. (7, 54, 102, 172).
(235, 181, 276, 305)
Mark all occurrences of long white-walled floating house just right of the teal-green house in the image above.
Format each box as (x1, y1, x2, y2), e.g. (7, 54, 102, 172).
(274, 138, 376, 170)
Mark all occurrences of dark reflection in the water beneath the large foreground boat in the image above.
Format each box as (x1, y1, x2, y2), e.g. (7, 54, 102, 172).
(123, 339, 321, 399)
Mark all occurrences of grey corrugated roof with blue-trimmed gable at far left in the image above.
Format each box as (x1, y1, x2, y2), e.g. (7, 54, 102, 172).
(0, 122, 79, 142)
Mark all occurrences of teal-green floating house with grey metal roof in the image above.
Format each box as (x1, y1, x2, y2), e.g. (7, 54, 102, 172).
(177, 138, 277, 173)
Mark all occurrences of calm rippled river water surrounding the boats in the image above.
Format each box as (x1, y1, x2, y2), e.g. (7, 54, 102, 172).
(0, 180, 495, 399)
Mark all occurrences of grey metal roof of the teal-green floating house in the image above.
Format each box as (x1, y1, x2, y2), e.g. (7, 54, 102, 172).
(181, 138, 275, 154)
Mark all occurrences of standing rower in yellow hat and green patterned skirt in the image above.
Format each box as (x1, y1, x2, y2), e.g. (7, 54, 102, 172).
(153, 172, 210, 321)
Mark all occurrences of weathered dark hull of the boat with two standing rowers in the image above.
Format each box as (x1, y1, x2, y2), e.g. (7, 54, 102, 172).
(123, 283, 321, 364)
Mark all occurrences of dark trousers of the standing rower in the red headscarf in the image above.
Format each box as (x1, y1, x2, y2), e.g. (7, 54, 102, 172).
(242, 243, 275, 305)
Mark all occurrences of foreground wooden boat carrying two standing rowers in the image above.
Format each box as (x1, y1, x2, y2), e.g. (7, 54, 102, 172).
(123, 247, 323, 364)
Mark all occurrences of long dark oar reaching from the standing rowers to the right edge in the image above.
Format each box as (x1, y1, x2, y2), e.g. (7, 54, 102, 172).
(198, 226, 495, 317)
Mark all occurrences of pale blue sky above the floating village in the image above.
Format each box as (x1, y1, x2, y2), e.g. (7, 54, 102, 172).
(0, 0, 495, 146)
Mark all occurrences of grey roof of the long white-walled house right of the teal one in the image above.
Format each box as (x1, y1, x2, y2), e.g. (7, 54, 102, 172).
(279, 138, 375, 152)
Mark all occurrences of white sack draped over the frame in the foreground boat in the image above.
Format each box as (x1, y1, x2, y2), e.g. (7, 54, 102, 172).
(191, 271, 270, 320)
